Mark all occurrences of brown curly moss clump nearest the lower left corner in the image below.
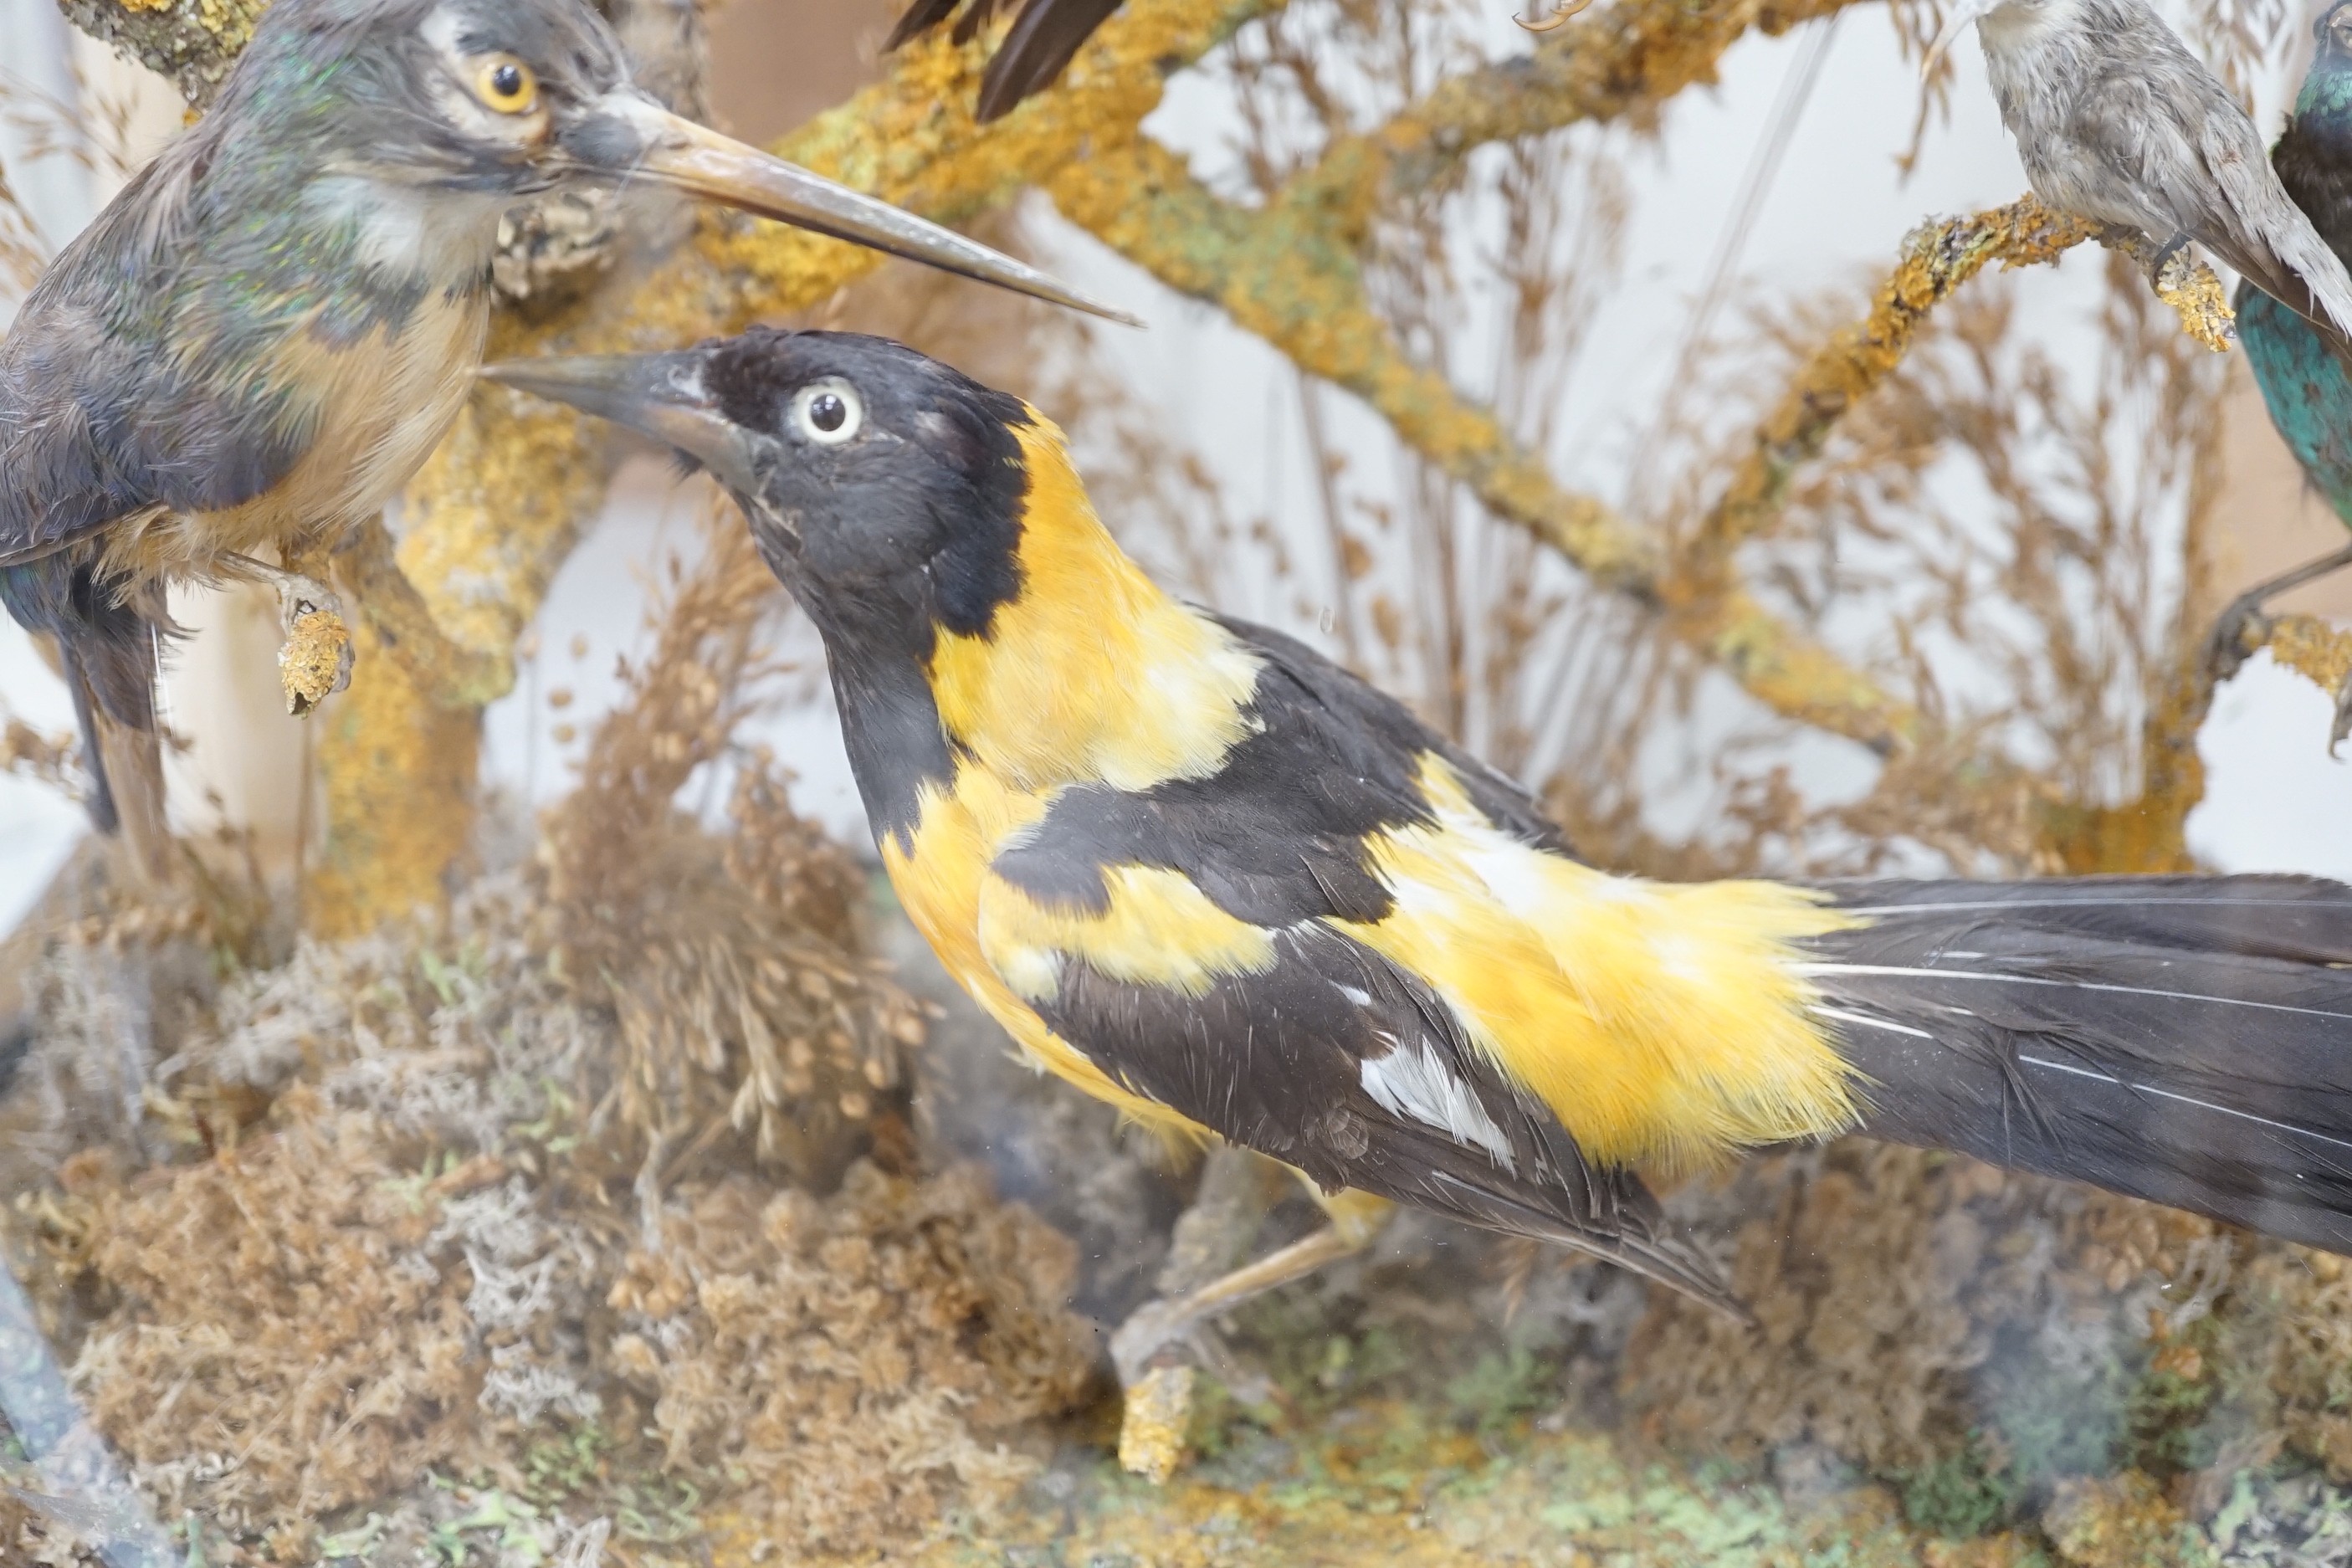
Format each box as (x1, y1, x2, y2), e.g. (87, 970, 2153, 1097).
(69, 1091, 496, 1530)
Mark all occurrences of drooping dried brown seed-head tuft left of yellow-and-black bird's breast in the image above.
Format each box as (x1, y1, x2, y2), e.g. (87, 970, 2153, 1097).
(541, 508, 922, 1185)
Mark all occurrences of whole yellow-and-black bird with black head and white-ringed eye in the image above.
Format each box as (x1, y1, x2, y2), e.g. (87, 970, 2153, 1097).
(489, 331, 2352, 1476)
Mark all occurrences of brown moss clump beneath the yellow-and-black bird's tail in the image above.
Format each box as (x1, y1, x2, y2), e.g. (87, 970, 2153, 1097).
(1625, 1140, 2230, 1486)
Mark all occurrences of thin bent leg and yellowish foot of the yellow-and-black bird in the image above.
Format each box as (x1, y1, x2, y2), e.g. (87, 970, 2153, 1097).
(1110, 1191, 1395, 1481)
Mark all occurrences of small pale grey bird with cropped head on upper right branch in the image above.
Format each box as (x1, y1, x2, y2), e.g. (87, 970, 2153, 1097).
(1924, 0, 2352, 357)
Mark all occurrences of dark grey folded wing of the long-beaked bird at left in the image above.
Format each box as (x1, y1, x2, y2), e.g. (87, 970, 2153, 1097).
(0, 127, 308, 564)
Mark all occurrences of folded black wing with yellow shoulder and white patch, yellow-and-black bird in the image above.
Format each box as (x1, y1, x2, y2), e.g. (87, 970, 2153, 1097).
(978, 625, 1726, 1304)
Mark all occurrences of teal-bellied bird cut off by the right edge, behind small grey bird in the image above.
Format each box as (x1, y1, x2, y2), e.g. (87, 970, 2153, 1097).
(2211, 0, 2352, 750)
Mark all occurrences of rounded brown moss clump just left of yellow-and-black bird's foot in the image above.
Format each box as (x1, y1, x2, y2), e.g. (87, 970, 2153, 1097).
(630, 1164, 1094, 1561)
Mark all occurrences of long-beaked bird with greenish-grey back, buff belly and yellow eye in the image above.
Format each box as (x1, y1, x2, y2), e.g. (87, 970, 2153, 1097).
(0, 0, 1120, 874)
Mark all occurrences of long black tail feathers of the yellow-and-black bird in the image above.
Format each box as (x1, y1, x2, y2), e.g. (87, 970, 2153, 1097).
(1806, 877, 2352, 1253)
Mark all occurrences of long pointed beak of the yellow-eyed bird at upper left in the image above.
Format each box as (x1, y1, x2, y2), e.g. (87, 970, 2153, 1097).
(583, 87, 1143, 327)
